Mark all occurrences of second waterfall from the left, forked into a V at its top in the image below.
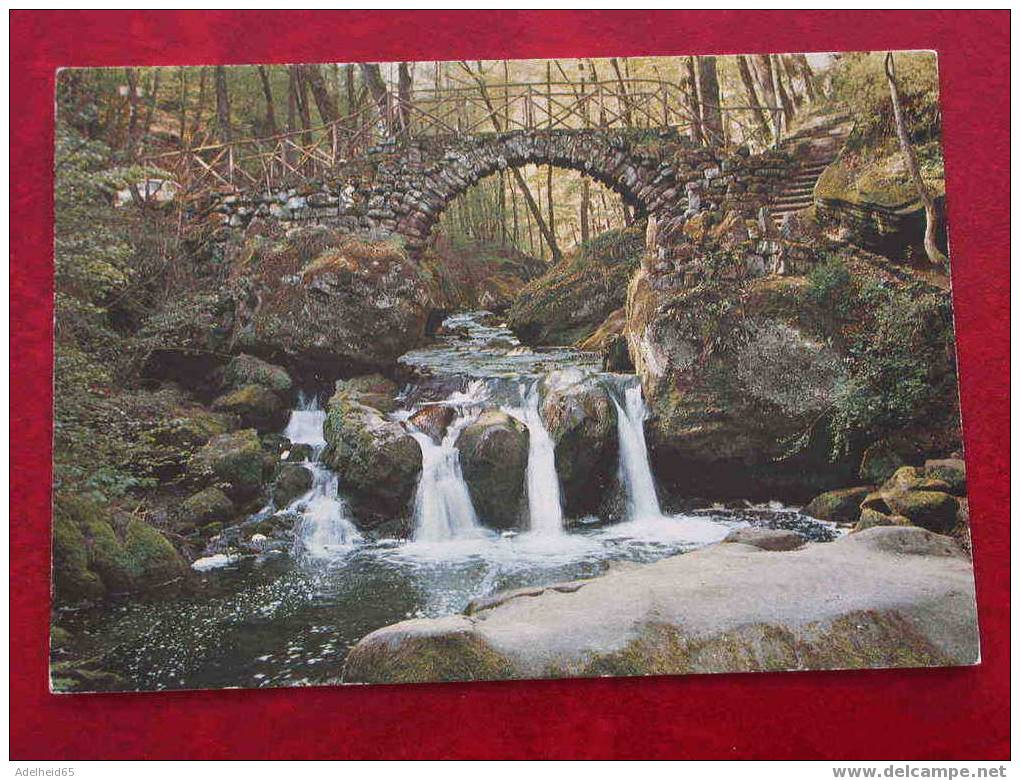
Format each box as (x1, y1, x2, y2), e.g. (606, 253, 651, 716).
(410, 413, 482, 542)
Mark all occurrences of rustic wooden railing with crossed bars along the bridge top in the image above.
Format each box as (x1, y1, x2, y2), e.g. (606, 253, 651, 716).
(144, 79, 778, 193)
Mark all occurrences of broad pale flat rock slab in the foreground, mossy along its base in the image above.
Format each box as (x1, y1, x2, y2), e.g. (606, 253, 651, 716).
(342, 526, 979, 682)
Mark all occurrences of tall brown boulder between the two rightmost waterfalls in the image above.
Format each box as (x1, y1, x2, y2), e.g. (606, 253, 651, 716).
(540, 369, 619, 517)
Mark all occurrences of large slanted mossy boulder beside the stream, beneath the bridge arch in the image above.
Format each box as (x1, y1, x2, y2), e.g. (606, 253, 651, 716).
(507, 226, 645, 345)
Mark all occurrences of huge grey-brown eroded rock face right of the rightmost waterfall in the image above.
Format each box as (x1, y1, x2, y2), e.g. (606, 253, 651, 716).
(626, 270, 851, 501)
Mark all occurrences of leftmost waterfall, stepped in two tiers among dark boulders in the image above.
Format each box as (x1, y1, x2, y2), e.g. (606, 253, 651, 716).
(284, 398, 361, 558)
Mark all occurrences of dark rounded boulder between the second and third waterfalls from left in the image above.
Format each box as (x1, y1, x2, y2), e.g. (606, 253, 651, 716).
(457, 411, 527, 529)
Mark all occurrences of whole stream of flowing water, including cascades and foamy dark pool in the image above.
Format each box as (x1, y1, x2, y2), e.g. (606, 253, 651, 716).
(60, 312, 837, 690)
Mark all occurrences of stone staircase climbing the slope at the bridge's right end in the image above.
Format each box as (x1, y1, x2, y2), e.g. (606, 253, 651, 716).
(769, 114, 852, 228)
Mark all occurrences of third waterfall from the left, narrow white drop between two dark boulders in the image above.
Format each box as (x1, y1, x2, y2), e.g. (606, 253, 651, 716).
(505, 382, 563, 535)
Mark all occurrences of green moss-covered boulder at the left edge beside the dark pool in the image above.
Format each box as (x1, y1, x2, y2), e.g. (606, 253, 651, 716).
(53, 496, 187, 604)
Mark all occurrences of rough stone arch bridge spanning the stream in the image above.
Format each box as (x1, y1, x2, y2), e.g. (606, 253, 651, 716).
(203, 128, 796, 258)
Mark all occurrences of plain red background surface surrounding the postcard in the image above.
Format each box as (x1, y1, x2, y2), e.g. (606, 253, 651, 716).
(10, 11, 1010, 759)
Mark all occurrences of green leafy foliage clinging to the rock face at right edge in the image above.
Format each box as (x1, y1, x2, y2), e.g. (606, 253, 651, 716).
(830, 285, 957, 455)
